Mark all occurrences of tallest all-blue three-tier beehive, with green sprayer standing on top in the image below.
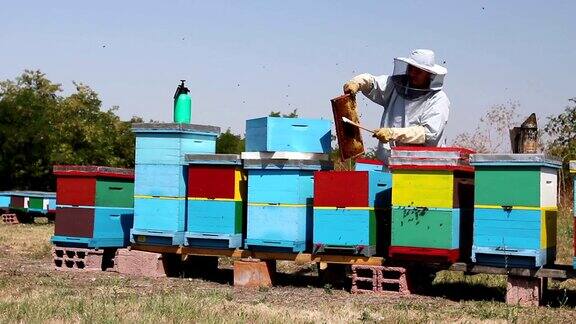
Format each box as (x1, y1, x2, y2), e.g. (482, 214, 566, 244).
(131, 123, 220, 245)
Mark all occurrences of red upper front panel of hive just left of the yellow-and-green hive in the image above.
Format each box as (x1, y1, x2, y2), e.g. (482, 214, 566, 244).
(314, 171, 369, 207)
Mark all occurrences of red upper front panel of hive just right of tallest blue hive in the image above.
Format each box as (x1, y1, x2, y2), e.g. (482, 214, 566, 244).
(188, 165, 236, 199)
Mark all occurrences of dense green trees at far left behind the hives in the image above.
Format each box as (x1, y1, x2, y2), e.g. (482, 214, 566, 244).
(0, 70, 141, 190)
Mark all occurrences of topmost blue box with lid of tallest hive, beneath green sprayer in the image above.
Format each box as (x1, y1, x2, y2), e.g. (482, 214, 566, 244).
(132, 123, 220, 165)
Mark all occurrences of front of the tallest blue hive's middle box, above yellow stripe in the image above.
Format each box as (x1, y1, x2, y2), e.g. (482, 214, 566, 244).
(134, 164, 187, 197)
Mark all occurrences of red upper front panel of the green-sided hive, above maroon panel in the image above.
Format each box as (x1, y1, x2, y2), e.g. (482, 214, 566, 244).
(56, 176, 96, 206)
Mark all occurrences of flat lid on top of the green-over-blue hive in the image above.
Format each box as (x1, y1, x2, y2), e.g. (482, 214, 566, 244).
(470, 154, 562, 168)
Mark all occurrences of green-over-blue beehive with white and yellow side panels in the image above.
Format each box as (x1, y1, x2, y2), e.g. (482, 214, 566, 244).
(472, 154, 561, 268)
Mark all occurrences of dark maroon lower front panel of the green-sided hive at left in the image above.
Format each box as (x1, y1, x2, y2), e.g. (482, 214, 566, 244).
(54, 208, 94, 237)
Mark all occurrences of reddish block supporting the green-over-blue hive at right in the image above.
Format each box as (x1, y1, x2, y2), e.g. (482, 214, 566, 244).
(506, 275, 548, 306)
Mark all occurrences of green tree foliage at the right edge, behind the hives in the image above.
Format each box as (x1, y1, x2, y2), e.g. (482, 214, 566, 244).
(544, 98, 576, 163)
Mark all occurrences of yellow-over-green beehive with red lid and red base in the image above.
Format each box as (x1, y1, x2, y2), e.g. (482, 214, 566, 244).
(388, 147, 474, 262)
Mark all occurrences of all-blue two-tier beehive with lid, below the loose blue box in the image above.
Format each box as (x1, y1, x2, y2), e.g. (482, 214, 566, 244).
(244, 160, 331, 252)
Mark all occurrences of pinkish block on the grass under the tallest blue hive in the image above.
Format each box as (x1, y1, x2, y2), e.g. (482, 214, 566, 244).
(115, 249, 181, 278)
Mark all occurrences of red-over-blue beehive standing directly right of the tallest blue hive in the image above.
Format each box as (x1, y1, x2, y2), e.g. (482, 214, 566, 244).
(185, 154, 246, 248)
